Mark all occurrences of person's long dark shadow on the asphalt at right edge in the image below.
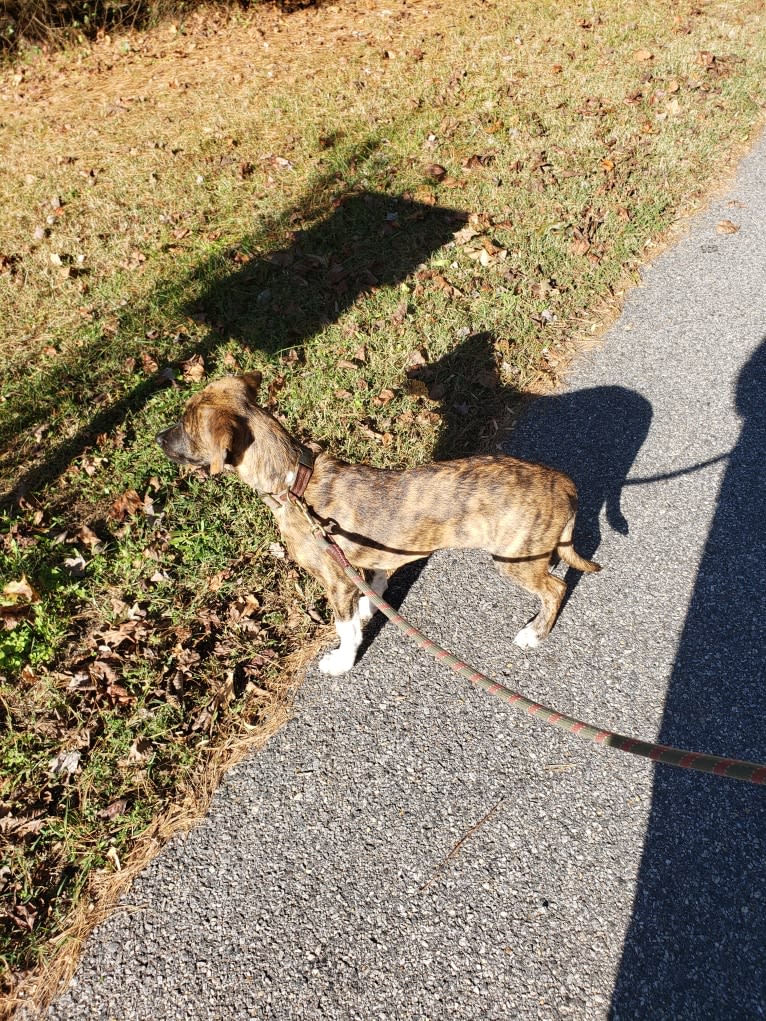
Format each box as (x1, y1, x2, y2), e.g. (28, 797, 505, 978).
(611, 341, 766, 1021)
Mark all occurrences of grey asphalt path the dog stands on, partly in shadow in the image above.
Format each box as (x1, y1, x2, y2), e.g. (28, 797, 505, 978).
(43, 138, 766, 1021)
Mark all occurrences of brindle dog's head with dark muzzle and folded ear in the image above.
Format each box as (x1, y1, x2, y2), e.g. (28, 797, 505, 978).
(156, 373, 260, 475)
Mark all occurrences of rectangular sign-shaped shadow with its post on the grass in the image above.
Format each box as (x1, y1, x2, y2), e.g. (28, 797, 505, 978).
(0, 169, 466, 506)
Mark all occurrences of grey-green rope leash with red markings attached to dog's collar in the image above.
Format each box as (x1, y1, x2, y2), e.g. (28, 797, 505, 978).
(295, 499, 766, 784)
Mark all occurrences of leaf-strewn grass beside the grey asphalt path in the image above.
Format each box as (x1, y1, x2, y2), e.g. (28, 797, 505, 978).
(0, 0, 766, 1004)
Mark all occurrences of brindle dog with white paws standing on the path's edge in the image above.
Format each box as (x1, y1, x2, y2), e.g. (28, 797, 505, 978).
(156, 373, 601, 675)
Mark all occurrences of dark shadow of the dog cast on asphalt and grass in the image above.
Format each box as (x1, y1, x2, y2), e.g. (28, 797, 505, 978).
(360, 333, 652, 655)
